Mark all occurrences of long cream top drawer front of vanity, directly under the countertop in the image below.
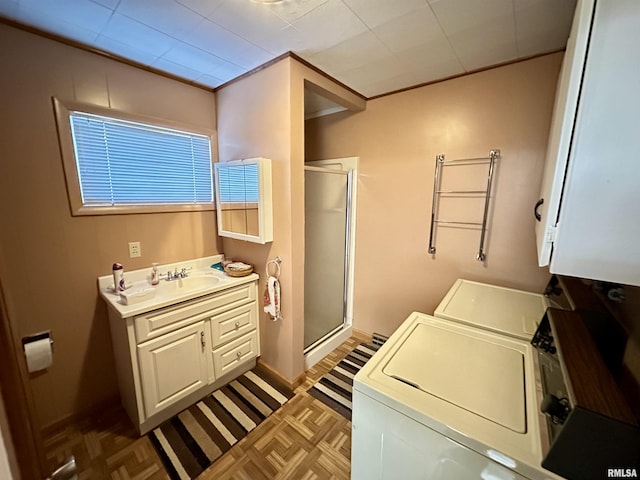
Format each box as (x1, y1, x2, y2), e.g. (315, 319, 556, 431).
(134, 282, 257, 343)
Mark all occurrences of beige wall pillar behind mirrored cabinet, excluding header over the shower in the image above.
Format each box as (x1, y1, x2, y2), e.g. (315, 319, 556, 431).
(216, 59, 299, 380)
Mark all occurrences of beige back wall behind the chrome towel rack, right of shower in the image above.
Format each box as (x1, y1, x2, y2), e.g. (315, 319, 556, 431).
(305, 54, 562, 334)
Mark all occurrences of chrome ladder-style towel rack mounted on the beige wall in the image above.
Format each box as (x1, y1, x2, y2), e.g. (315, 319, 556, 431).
(429, 149, 500, 262)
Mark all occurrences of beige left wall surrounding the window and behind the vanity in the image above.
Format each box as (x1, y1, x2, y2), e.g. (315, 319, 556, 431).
(0, 24, 219, 425)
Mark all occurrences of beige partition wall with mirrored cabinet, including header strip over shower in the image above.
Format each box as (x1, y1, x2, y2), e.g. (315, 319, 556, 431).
(216, 54, 364, 381)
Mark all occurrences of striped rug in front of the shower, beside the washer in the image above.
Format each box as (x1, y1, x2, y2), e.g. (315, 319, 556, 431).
(308, 343, 380, 420)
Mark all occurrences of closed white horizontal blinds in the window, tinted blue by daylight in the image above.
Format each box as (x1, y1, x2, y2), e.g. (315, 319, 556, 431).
(70, 112, 213, 207)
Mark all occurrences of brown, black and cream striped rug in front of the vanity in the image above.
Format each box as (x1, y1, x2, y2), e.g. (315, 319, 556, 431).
(149, 368, 294, 480)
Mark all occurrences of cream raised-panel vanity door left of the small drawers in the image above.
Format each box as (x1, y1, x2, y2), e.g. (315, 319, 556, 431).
(138, 321, 210, 418)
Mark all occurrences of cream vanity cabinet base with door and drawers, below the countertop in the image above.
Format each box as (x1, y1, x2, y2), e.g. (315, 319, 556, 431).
(109, 275, 260, 434)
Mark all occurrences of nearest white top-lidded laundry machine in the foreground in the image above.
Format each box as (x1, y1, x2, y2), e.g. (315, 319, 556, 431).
(351, 312, 559, 480)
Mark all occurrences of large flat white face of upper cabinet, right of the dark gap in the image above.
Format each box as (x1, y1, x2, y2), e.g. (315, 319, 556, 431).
(550, 0, 640, 285)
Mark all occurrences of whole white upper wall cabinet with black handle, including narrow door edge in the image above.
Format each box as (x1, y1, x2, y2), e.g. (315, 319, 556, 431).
(536, 0, 640, 285)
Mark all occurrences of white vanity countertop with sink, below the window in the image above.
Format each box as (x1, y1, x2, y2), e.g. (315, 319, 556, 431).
(98, 255, 259, 318)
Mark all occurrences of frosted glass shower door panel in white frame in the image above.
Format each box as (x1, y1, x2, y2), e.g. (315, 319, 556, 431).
(304, 166, 351, 351)
